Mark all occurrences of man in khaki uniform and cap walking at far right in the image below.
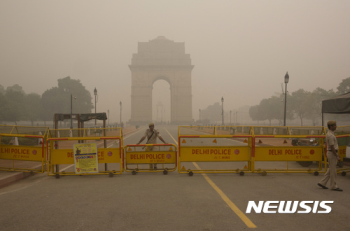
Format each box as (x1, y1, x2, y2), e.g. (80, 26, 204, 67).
(317, 120, 343, 192)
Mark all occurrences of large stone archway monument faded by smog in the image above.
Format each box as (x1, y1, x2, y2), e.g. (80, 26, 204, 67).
(129, 36, 194, 124)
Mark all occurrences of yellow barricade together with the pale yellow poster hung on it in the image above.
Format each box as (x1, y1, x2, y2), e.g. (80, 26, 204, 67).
(47, 128, 123, 178)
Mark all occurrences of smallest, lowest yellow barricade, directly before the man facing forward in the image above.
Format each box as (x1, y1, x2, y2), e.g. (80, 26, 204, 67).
(123, 144, 177, 175)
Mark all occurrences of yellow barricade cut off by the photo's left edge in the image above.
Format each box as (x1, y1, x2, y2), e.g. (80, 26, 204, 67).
(0, 125, 48, 173)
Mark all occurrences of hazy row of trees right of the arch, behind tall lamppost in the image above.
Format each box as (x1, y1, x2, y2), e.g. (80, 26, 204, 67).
(249, 77, 350, 126)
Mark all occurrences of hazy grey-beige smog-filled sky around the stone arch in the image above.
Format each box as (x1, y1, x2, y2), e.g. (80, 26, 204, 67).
(0, 0, 350, 121)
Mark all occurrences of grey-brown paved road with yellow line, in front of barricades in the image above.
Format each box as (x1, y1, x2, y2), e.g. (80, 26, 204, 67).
(0, 126, 350, 231)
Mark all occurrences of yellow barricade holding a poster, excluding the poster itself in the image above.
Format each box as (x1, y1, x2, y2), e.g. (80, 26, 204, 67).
(47, 128, 123, 178)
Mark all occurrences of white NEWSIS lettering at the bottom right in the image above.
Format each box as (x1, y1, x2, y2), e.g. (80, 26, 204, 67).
(246, 201, 334, 213)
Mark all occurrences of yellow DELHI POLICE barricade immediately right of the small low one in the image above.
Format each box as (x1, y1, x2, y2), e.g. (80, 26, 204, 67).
(178, 126, 254, 176)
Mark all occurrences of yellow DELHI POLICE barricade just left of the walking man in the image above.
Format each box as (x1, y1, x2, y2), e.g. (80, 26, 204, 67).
(252, 126, 326, 175)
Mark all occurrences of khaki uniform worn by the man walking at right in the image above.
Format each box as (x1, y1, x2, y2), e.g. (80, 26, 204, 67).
(319, 126, 339, 189)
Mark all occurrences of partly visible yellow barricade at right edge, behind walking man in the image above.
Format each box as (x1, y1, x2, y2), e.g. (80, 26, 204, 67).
(335, 126, 350, 176)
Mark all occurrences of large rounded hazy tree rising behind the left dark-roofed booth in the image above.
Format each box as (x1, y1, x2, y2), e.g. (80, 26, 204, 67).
(41, 76, 94, 119)
